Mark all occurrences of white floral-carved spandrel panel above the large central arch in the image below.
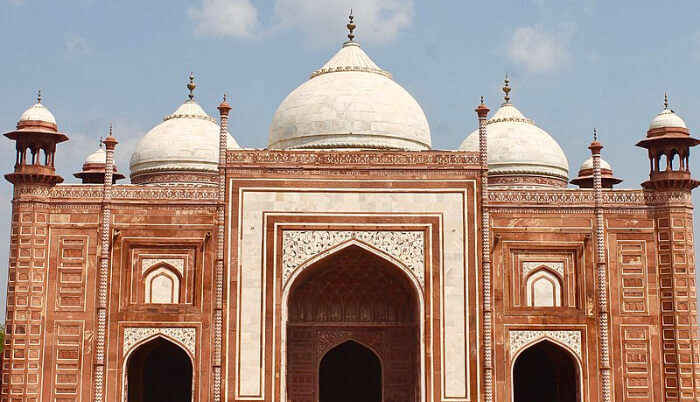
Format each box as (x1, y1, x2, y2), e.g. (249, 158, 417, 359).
(282, 230, 425, 287)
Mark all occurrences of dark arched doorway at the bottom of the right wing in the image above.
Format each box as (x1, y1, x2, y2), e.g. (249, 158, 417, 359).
(513, 340, 581, 402)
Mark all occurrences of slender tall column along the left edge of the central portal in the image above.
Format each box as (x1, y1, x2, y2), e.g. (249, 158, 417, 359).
(213, 95, 231, 402)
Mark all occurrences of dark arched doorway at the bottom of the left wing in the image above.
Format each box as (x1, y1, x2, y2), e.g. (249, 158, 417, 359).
(126, 337, 192, 402)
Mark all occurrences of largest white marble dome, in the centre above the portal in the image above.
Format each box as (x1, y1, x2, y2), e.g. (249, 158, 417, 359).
(268, 41, 431, 151)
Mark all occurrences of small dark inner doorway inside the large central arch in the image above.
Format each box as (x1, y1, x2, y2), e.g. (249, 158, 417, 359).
(319, 341, 382, 402)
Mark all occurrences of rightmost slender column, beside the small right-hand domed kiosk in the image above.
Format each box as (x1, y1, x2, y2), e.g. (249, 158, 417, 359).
(588, 129, 610, 402)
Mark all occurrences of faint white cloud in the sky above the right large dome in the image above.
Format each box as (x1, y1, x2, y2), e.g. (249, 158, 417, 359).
(508, 26, 573, 72)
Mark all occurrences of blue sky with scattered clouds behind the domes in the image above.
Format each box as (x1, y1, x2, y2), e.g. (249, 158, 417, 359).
(0, 0, 700, 320)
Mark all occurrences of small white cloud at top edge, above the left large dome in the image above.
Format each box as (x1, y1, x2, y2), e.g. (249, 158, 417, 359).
(189, 0, 258, 38)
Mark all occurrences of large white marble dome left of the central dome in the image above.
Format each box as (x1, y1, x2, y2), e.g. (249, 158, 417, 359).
(129, 99, 240, 178)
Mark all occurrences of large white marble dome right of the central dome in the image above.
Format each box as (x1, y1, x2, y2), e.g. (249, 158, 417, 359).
(459, 103, 569, 181)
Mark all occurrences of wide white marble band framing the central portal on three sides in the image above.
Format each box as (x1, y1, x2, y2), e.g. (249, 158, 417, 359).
(236, 188, 475, 400)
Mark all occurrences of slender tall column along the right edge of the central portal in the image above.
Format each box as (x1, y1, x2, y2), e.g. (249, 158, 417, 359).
(475, 96, 493, 402)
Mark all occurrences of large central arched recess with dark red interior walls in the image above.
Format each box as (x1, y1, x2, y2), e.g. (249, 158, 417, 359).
(286, 245, 420, 402)
